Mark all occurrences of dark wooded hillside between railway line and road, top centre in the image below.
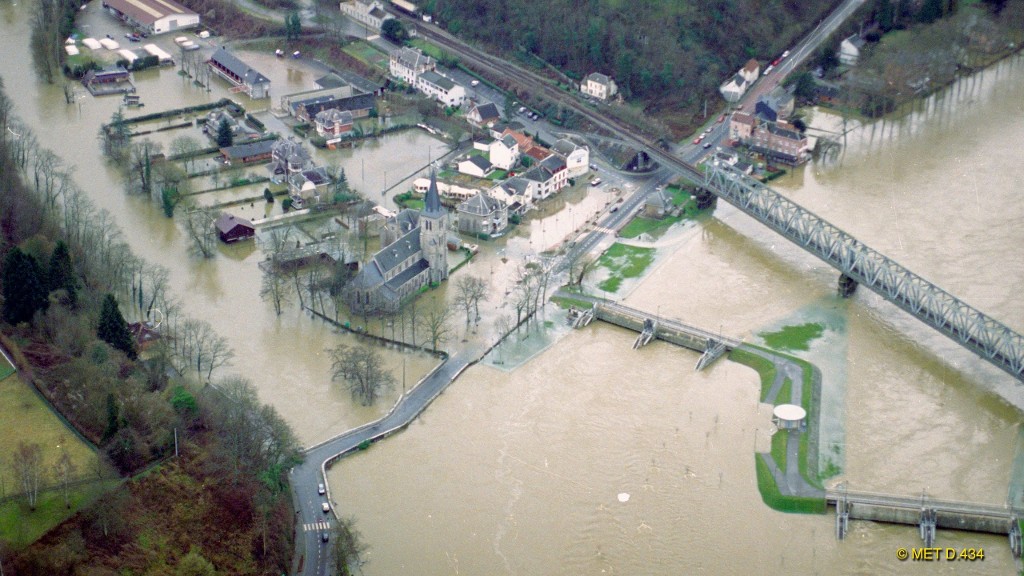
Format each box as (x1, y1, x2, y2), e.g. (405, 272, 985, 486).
(424, 0, 833, 107)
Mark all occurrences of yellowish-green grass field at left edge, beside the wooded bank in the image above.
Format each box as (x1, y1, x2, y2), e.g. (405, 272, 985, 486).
(0, 368, 118, 546)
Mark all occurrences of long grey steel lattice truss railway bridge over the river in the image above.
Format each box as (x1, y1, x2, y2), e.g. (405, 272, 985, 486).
(705, 165, 1024, 381)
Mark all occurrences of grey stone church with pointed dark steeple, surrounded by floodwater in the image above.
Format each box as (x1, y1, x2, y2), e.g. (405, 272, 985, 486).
(347, 170, 449, 314)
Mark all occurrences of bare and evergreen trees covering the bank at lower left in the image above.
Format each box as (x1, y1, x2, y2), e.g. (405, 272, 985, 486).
(0, 76, 299, 574)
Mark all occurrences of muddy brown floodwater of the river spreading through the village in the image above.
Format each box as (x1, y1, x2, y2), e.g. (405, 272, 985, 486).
(0, 0, 1024, 576)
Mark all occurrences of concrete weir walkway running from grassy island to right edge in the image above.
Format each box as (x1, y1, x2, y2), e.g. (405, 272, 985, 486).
(825, 488, 1024, 558)
